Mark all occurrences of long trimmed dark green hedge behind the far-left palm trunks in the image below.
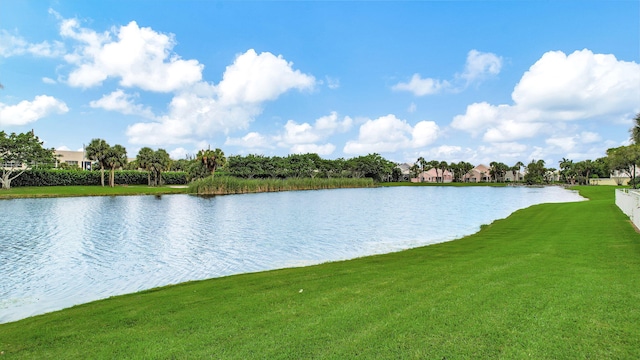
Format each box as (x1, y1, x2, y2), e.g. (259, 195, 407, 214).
(11, 169, 187, 187)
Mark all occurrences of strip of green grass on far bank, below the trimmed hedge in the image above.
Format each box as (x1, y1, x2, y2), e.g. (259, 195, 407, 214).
(0, 185, 186, 199)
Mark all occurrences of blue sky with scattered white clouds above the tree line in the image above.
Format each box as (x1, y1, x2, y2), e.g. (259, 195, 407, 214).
(0, 0, 640, 167)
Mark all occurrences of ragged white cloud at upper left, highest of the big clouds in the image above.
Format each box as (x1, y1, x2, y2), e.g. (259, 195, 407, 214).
(60, 19, 203, 92)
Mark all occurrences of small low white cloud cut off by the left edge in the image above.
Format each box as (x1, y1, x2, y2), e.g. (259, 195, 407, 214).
(0, 95, 69, 126)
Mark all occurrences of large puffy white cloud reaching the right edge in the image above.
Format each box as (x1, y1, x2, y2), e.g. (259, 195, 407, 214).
(451, 49, 640, 142)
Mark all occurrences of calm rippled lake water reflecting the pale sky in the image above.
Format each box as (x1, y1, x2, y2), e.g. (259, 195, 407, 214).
(0, 187, 583, 323)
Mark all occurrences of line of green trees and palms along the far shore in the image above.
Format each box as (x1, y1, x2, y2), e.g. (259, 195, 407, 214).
(0, 113, 640, 189)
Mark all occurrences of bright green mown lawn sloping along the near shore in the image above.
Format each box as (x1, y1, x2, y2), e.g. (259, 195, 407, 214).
(0, 186, 640, 359)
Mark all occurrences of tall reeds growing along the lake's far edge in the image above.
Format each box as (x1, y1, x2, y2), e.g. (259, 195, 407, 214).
(188, 176, 375, 195)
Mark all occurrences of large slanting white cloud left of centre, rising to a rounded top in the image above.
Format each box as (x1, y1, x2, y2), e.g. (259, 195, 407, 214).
(127, 49, 315, 145)
